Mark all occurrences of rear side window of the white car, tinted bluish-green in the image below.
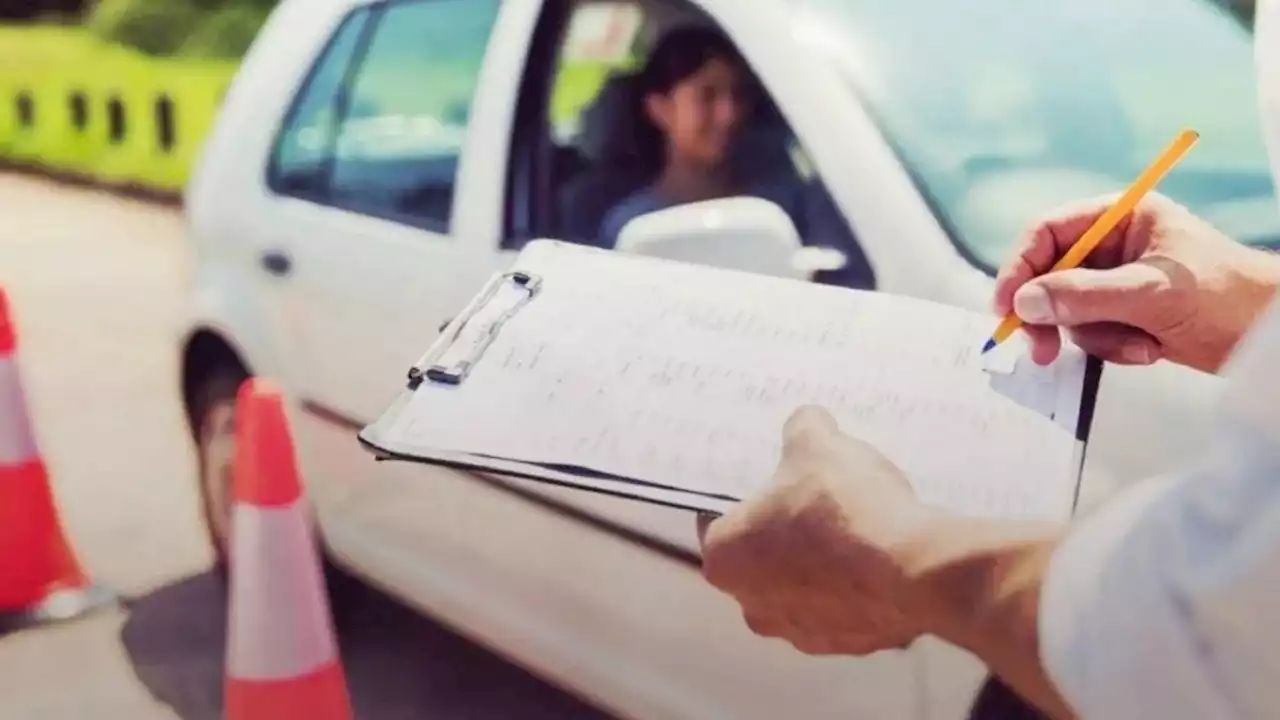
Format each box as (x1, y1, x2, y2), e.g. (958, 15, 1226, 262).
(267, 0, 500, 232)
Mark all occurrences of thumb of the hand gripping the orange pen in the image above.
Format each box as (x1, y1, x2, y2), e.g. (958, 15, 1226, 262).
(1014, 261, 1170, 327)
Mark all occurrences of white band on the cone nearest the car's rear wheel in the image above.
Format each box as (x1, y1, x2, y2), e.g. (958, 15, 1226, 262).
(227, 500, 338, 680)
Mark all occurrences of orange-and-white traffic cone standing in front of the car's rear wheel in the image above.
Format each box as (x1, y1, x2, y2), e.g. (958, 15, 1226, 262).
(225, 378, 352, 720)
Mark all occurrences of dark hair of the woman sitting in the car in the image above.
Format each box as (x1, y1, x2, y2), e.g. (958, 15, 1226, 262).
(635, 26, 746, 164)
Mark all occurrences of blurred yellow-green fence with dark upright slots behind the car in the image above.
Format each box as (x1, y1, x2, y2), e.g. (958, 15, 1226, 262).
(0, 27, 236, 191)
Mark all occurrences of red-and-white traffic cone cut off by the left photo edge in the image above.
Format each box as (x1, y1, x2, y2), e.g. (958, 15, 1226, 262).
(0, 288, 115, 633)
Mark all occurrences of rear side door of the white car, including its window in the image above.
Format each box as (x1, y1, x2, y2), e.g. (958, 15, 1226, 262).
(264, 0, 500, 510)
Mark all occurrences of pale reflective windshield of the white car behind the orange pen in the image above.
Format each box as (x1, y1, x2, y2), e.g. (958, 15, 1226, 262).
(796, 0, 1280, 269)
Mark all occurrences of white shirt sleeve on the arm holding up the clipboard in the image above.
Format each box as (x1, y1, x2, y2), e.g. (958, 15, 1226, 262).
(1039, 294, 1280, 720)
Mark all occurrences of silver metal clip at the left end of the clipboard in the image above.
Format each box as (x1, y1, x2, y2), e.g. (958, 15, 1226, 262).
(408, 272, 541, 389)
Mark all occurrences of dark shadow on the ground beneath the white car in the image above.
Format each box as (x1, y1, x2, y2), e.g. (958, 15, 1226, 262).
(120, 574, 608, 720)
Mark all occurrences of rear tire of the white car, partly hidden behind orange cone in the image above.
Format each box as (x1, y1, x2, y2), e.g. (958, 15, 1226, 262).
(191, 363, 362, 625)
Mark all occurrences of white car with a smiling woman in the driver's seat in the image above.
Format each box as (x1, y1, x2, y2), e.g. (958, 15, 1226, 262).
(182, 0, 1280, 719)
